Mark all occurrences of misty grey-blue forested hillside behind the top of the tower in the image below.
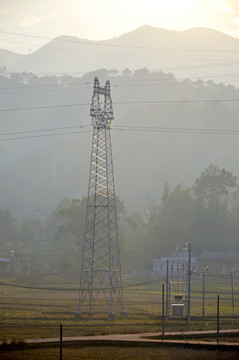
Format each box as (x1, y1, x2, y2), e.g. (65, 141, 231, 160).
(0, 68, 239, 220)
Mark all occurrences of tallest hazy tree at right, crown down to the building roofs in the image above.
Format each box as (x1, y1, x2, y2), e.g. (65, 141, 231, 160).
(192, 164, 238, 251)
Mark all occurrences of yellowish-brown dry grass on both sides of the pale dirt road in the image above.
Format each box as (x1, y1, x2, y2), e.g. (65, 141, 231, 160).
(0, 277, 239, 360)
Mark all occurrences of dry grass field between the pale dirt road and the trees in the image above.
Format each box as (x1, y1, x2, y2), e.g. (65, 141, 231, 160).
(0, 277, 239, 341)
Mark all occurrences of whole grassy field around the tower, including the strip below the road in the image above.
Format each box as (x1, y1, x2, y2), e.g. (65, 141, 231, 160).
(0, 276, 239, 360)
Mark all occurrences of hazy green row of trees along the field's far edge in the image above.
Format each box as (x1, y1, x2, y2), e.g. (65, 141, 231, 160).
(0, 164, 239, 272)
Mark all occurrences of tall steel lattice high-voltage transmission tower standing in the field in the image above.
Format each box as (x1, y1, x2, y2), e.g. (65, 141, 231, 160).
(75, 78, 127, 320)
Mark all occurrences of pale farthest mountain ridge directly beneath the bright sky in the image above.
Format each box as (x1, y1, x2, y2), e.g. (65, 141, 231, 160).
(5, 25, 239, 82)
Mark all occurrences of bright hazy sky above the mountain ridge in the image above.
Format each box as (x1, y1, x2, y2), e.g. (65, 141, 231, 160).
(0, 0, 239, 53)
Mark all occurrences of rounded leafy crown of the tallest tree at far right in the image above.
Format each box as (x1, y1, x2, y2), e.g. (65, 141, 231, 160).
(192, 164, 238, 207)
